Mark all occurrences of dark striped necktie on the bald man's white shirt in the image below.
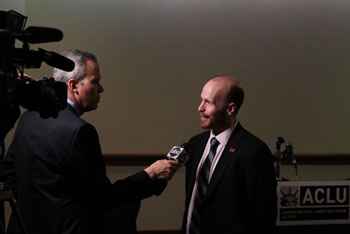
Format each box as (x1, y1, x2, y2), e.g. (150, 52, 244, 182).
(189, 137, 220, 234)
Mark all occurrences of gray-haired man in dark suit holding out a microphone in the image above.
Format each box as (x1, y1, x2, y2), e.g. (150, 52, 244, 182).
(3, 50, 176, 234)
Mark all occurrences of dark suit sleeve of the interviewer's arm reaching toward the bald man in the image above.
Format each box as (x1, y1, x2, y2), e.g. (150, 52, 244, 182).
(64, 124, 164, 208)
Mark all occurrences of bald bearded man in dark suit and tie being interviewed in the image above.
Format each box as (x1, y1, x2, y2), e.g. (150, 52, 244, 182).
(183, 76, 276, 234)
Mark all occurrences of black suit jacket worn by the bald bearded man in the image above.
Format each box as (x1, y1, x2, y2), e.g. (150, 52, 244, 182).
(183, 124, 276, 234)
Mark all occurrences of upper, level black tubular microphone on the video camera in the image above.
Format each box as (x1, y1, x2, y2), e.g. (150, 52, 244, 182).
(14, 26, 63, 44)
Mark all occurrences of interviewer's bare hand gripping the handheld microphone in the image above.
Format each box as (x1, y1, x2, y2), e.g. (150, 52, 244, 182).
(145, 159, 180, 180)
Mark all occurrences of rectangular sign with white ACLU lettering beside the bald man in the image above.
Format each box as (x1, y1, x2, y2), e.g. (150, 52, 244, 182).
(277, 181, 350, 226)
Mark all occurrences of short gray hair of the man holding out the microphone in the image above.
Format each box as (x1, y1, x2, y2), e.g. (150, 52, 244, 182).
(52, 50, 97, 82)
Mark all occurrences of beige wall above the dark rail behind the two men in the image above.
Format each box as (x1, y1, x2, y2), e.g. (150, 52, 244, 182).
(9, 0, 350, 154)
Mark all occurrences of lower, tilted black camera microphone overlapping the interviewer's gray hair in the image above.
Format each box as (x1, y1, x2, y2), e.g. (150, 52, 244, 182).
(38, 48, 75, 72)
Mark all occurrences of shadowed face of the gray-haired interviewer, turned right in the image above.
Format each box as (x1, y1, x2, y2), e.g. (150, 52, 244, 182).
(76, 60, 103, 112)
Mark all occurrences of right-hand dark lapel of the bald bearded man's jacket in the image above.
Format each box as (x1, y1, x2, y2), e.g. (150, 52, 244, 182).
(206, 123, 243, 198)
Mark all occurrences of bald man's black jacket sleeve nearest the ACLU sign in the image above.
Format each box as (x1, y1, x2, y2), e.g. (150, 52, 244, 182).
(245, 144, 277, 233)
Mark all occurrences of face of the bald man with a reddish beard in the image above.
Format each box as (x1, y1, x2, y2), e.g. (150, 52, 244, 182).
(198, 81, 227, 132)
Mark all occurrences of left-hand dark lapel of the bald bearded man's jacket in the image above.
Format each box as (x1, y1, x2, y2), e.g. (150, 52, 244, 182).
(188, 132, 210, 196)
